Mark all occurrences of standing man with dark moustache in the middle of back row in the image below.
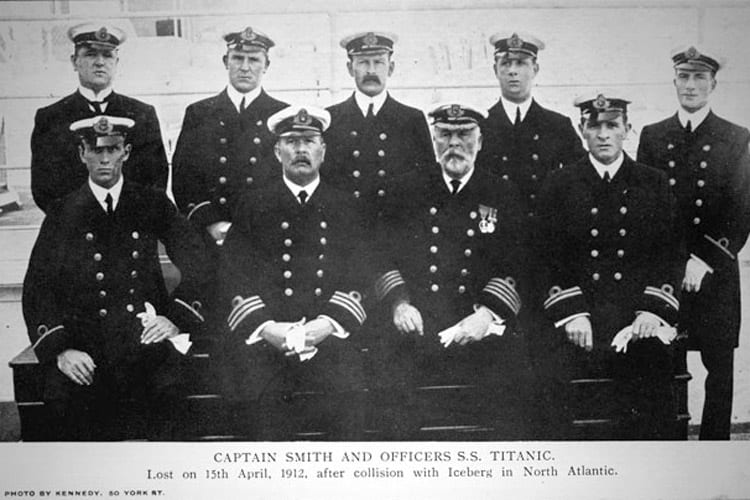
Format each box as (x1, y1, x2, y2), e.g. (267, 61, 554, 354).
(323, 31, 435, 216)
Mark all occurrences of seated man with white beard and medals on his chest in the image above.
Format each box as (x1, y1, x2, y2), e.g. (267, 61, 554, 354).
(375, 103, 526, 439)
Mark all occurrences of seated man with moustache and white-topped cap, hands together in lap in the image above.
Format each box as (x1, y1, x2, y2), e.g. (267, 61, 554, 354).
(219, 106, 366, 440)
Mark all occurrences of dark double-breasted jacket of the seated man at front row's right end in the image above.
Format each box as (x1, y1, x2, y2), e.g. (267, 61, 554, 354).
(537, 155, 682, 350)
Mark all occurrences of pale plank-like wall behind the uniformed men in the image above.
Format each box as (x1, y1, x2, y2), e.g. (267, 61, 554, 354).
(0, 0, 750, 428)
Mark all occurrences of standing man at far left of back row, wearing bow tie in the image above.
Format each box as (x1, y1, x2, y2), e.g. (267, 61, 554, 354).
(31, 23, 169, 212)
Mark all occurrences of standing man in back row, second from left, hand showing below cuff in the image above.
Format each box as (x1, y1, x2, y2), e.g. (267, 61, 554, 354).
(172, 26, 287, 248)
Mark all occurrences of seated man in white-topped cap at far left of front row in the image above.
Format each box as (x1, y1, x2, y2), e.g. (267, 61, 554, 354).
(23, 116, 203, 440)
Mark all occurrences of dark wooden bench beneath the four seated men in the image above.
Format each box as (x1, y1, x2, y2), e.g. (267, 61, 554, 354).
(10, 338, 691, 441)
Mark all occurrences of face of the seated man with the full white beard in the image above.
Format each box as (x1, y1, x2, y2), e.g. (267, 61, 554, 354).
(432, 123, 482, 179)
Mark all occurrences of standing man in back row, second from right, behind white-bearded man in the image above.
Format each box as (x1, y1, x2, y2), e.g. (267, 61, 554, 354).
(477, 33, 586, 217)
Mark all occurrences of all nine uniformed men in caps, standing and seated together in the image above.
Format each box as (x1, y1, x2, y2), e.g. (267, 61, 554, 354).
(23, 23, 750, 440)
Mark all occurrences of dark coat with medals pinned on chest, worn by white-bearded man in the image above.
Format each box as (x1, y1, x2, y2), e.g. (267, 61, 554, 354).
(375, 164, 525, 385)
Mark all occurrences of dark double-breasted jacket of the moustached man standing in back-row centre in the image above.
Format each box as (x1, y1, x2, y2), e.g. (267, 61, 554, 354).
(321, 94, 435, 221)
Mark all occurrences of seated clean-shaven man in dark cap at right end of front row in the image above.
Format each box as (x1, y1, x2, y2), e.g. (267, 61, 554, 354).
(538, 94, 681, 439)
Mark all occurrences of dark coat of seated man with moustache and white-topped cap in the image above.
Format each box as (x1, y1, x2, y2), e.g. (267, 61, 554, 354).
(219, 178, 366, 398)
